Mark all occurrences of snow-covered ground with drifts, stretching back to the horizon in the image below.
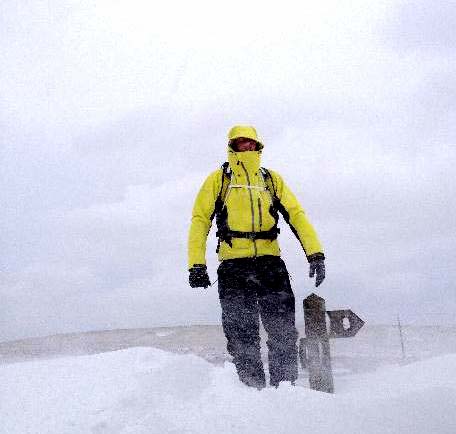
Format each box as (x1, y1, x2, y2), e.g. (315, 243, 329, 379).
(0, 327, 456, 434)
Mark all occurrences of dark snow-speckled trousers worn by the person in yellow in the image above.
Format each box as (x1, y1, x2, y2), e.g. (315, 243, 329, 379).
(218, 256, 298, 388)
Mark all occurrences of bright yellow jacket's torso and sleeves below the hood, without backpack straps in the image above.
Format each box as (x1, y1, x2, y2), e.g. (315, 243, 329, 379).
(188, 148, 323, 269)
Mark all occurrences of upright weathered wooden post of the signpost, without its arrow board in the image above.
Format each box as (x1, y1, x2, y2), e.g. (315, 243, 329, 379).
(301, 294, 334, 393)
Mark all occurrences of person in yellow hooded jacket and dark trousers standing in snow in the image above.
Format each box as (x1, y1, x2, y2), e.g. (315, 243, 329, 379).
(188, 125, 325, 389)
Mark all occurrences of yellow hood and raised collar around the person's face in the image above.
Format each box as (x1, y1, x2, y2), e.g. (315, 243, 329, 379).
(228, 125, 264, 173)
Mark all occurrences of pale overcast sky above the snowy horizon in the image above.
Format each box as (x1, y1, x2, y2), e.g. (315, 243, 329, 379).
(0, 0, 456, 340)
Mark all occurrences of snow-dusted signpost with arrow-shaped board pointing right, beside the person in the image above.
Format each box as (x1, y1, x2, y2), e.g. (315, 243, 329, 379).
(299, 294, 364, 393)
